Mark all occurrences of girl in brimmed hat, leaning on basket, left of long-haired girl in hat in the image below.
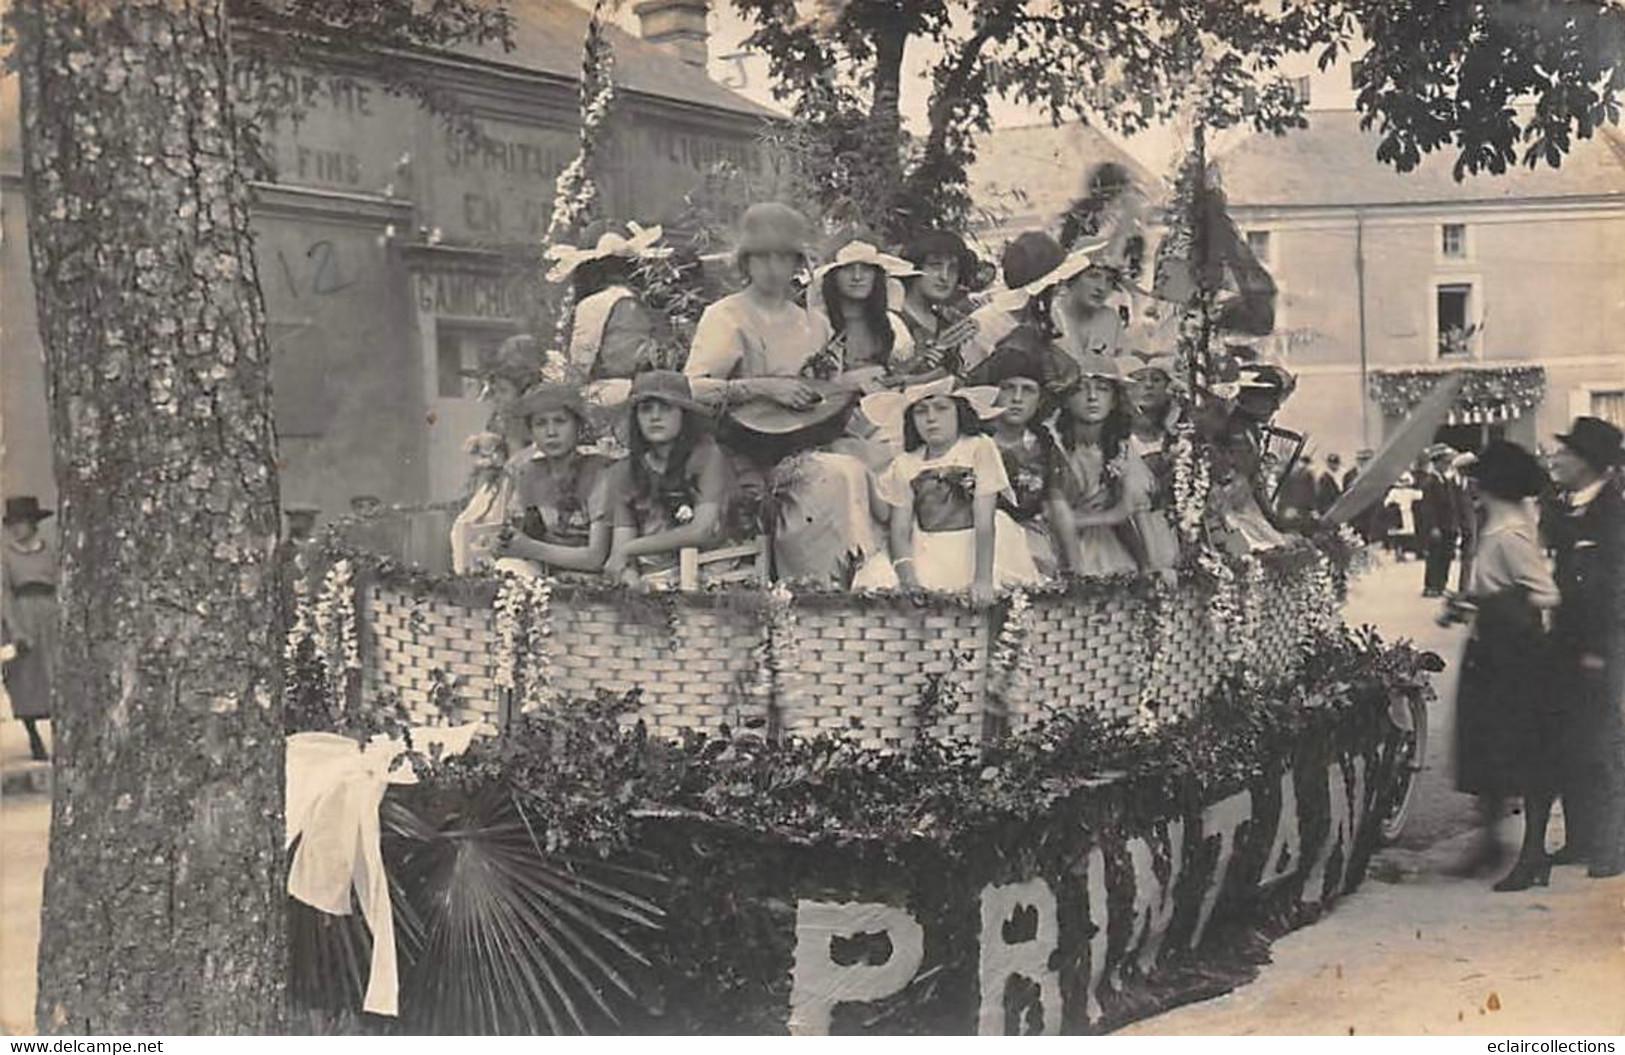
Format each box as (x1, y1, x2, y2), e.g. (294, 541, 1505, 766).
(496, 382, 613, 572)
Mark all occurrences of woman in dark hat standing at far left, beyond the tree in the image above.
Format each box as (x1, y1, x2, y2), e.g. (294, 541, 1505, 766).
(0, 496, 57, 761)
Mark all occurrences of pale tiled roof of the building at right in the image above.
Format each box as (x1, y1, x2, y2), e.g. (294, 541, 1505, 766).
(1219, 111, 1625, 206)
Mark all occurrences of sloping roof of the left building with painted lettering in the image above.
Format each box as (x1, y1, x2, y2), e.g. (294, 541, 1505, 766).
(455, 0, 778, 119)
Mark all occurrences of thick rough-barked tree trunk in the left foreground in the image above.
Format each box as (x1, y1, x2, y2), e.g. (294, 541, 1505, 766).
(16, 0, 284, 1034)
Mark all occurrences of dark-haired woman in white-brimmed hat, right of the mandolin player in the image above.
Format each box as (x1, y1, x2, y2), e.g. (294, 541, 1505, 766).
(813, 232, 913, 369)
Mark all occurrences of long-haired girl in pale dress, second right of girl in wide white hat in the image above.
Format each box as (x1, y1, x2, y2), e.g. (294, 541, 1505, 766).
(1055, 354, 1152, 575)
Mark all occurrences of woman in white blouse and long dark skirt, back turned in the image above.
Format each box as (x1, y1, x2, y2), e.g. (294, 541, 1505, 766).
(1456, 441, 1565, 891)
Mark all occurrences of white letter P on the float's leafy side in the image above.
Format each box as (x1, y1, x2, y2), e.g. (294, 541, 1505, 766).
(790, 897, 923, 1035)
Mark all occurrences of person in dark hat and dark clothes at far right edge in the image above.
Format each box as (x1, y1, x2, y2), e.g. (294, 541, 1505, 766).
(1542, 418, 1625, 878)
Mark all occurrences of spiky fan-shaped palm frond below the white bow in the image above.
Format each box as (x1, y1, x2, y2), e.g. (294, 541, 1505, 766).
(390, 785, 663, 1034)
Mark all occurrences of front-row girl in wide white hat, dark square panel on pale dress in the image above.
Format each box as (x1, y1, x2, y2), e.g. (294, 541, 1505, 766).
(863, 377, 1040, 603)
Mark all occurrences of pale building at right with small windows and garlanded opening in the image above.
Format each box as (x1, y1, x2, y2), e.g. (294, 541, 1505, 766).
(1219, 111, 1625, 463)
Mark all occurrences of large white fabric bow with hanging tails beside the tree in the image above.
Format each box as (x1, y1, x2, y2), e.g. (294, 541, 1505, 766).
(284, 722, 481, 1014)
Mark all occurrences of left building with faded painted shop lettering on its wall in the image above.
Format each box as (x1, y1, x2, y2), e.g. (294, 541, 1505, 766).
(0, 0, 772, 517)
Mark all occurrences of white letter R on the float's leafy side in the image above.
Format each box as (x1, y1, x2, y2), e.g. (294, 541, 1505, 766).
(977, 879, 1061, 1037)
